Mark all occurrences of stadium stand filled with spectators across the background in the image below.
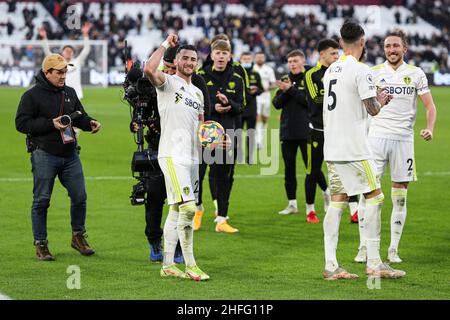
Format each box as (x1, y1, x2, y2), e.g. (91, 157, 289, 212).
(0, 0, 450, 72)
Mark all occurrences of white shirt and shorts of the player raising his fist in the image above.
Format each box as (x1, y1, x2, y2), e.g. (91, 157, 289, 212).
(156, 74, 204, 205)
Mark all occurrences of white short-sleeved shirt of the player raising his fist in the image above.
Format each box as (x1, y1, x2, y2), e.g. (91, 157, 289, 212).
(156, 74, 204, 164)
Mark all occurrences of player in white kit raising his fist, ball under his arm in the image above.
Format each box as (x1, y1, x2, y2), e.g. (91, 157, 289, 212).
(144, 34, 209, 281)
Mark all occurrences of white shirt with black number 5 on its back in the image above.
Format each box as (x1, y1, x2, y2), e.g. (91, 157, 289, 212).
(323, 56, 376, 161)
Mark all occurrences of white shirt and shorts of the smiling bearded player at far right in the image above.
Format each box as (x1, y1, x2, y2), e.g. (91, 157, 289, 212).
(369, 61, 430, 182)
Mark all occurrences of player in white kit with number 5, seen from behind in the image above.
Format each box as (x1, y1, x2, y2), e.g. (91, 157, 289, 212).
(323, 21, 406, 280)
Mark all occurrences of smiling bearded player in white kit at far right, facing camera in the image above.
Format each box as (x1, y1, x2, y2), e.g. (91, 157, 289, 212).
(355, 31, 436, 263)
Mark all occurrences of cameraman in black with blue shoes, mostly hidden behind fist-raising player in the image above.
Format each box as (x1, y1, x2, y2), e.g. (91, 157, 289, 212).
(130, 46, 210, 264)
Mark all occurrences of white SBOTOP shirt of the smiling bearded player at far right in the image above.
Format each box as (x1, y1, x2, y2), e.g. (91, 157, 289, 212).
(369, 61, 430, 141)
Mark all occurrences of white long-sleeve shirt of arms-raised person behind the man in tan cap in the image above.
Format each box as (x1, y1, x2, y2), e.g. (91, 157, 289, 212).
(43, 37, 91, 100)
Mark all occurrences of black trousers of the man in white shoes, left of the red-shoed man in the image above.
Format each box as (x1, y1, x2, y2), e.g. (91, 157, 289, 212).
(281, 139, 308, 200)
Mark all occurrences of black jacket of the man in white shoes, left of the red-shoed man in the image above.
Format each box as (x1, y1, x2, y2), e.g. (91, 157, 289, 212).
(272, 72, 309, 141)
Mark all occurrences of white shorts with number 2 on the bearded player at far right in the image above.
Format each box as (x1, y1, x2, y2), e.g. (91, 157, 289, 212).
(369, 137, 417, 182)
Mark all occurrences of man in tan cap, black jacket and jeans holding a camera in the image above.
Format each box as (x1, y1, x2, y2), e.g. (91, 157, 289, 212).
(16, 54, 101, 261)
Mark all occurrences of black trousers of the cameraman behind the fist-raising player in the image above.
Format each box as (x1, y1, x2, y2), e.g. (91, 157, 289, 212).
(145, 172, 167, 243)
